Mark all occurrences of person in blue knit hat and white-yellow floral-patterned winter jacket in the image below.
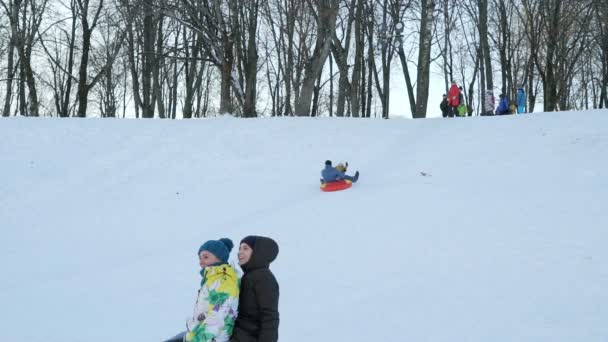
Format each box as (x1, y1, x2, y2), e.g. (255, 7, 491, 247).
(166, 238, 240, 342)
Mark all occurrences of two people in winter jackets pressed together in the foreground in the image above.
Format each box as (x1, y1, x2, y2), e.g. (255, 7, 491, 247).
(165, 236, 279, 342)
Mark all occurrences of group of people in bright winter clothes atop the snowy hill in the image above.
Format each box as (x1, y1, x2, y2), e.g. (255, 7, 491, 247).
(439, 81, 526, 118)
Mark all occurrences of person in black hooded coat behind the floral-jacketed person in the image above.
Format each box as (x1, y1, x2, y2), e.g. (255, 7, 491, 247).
(230, 236, 279, 342)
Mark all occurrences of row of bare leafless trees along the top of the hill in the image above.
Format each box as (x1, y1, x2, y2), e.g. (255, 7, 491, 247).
(0, 0, 608, 119)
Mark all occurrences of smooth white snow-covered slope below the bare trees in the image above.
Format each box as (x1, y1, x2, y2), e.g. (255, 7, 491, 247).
(0, 111, 608, 342)
